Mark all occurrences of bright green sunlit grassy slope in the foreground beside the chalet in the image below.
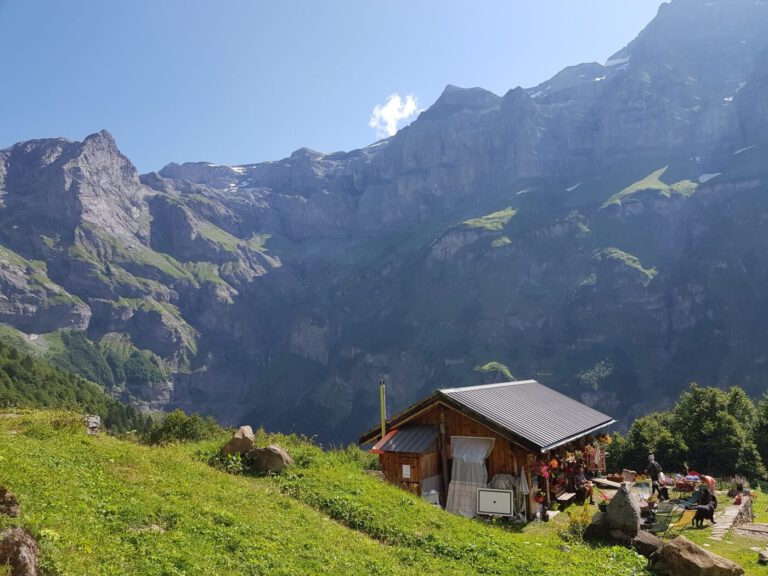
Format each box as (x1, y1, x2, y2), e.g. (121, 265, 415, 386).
(0, 412, 645, 576)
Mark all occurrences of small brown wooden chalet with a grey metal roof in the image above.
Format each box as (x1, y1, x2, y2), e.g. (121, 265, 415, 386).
(360, 380, 615, 517)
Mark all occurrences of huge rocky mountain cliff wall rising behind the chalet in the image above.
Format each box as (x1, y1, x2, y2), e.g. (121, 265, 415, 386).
(0, 0, 768, 440)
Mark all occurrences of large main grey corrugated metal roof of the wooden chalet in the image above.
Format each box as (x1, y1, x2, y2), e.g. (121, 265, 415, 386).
(440, 380, 614, 451)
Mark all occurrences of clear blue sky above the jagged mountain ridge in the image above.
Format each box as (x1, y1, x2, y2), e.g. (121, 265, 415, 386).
(0, 0, 661, 172)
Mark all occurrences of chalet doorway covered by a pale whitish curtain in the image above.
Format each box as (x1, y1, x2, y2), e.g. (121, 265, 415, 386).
(445, 436, 494, 517)
